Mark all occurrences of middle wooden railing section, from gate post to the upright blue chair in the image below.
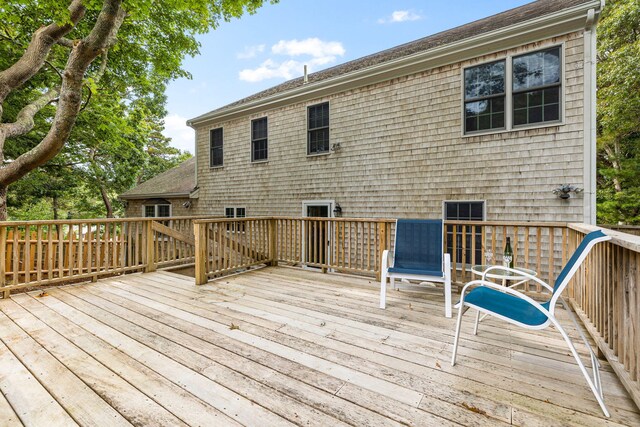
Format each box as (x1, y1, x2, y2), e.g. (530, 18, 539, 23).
(194, 217, 395, 284)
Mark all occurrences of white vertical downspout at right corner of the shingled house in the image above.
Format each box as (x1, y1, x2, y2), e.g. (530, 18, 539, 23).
(583, 0, 604, 225)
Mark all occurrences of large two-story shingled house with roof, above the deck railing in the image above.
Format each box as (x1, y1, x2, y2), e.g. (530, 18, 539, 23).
(132, 0, 602, 223)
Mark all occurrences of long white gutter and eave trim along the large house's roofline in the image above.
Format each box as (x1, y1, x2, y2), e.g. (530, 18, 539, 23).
(187, 0, 602, 129)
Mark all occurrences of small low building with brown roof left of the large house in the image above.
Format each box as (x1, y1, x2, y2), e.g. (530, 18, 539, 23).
(120, 157, 198, 217)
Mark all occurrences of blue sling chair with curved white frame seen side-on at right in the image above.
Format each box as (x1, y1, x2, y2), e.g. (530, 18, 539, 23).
(451, 230, 611, 417)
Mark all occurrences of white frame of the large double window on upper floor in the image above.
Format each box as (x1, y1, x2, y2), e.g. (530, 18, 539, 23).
(460, 41, 567, 137)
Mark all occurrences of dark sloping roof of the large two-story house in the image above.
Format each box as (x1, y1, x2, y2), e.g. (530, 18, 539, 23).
(187, 0, 599, 125)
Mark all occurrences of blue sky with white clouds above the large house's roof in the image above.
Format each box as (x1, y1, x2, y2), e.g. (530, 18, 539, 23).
(164, 0, 530, 153)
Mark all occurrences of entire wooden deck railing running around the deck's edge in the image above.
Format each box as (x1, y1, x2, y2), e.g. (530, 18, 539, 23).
(0, 217, 640, 405)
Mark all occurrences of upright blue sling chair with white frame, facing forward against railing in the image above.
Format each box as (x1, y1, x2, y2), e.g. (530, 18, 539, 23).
(380, 219, 451, 317)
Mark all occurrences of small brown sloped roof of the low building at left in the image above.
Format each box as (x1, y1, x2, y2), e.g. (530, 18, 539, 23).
(120, 157, 196, 199)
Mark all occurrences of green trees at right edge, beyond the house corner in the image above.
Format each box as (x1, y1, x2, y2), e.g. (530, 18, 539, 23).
(597, 0, 640, 224)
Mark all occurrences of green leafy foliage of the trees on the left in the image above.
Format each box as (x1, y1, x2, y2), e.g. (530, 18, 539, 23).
(0, 0, 274, 219)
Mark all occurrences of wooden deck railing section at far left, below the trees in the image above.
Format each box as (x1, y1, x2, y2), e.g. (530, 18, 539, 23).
(0, 217, 215, 297)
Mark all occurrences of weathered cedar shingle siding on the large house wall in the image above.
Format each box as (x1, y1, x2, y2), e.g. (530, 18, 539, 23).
(188, 1, 587, 222)
